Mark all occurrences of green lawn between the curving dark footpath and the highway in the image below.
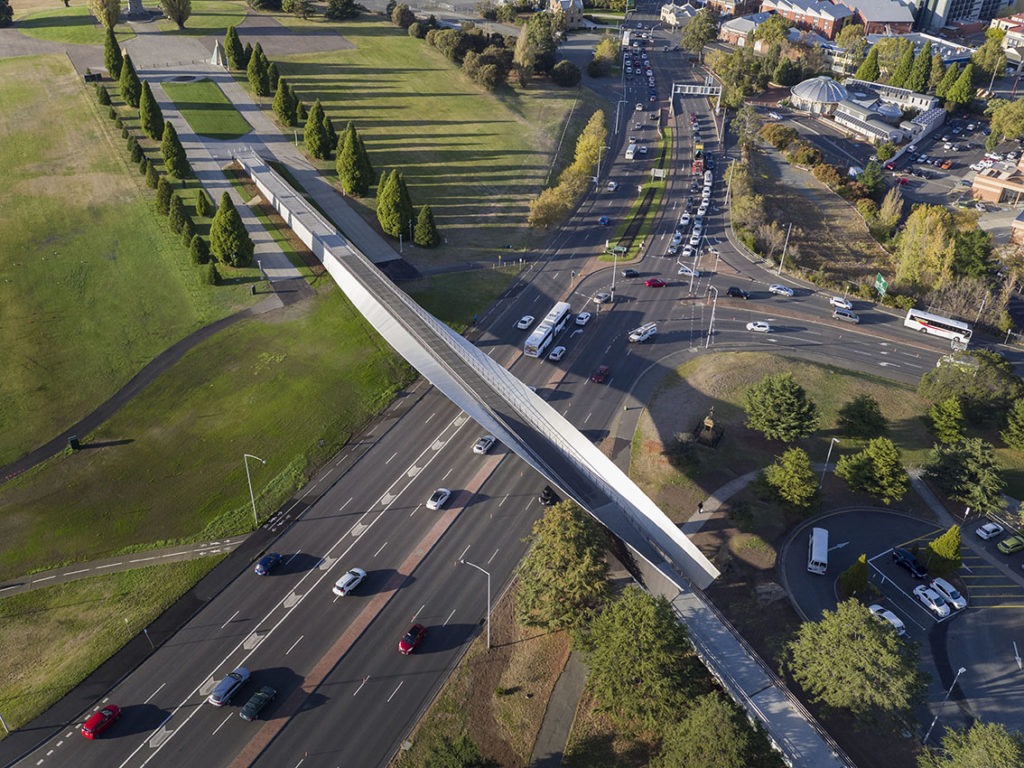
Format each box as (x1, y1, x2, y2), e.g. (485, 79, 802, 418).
(0, 284, 412, 579)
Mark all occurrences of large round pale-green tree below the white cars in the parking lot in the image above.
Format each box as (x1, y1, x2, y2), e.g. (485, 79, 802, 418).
(783, 600, 927, 718)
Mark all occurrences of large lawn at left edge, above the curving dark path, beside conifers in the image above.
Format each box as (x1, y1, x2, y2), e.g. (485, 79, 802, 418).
(0, 54, 248, 464)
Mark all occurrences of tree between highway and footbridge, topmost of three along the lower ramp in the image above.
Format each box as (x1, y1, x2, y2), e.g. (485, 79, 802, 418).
(515, 501, 611, 630)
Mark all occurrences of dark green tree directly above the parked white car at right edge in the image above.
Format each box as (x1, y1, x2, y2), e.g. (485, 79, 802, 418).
(927, 437, 1006, 514)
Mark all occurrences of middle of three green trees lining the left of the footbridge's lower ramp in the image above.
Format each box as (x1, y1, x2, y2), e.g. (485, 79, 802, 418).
(581, 587, 702, 729)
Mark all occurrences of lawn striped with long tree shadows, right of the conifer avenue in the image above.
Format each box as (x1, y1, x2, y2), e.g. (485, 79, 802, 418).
(276, 16, 597, 264)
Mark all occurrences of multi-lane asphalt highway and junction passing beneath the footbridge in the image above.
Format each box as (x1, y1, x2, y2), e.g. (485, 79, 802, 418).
(6, 16, 966, 768)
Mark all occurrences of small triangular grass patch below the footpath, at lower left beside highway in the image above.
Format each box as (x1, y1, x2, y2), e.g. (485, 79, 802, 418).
(0, 556, 221, 737)
